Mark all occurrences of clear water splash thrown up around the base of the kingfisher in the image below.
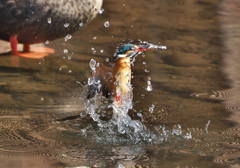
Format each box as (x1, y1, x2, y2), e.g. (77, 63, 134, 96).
(82, 59, 192, 145)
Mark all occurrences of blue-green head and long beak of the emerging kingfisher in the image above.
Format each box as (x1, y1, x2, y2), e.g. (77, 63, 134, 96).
(114, 44, 151, 61)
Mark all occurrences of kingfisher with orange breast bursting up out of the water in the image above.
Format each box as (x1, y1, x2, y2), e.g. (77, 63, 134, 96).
(87, 44, 163, 106)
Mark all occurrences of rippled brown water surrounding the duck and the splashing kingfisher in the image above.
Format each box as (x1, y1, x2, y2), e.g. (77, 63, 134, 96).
(0, 0, 240, 168)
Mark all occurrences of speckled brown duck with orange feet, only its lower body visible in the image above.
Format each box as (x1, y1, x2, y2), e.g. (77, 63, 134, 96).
(0, 0, 102, 58)
